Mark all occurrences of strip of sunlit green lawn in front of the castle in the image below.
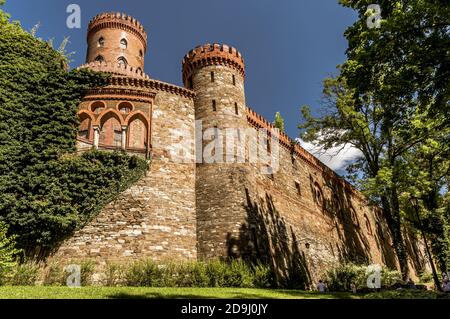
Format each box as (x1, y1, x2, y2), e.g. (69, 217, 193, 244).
(0, 286, 450, 299)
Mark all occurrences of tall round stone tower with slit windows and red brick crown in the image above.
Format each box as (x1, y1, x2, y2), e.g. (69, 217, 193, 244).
(183, 44, 253, 259)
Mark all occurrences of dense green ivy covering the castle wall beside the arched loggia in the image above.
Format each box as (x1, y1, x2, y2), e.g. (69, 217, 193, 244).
(0, 5, 147, 259)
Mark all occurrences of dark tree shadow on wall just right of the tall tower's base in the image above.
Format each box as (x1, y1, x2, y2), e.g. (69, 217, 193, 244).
(227, 189, 311, 290)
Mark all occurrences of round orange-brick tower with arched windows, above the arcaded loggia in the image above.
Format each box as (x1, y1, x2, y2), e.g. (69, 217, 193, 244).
(86, 12, 147, 72)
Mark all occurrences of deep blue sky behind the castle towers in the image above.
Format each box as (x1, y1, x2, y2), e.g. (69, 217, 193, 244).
(4, 0, 357, 170)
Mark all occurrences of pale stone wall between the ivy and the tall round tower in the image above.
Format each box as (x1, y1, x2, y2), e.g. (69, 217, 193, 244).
(54, 91, 197, 263)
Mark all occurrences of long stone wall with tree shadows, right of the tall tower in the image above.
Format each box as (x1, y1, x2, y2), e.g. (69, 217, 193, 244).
(230, 117, 424, 284)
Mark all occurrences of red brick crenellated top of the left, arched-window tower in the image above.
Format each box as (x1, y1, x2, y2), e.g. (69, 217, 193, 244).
(87, 12, 147, 50)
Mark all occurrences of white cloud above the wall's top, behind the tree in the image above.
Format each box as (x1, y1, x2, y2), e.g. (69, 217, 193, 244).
(297, 138, 362, 171)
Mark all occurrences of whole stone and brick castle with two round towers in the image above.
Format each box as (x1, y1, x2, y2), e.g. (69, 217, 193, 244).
(55, 13, 426, 278)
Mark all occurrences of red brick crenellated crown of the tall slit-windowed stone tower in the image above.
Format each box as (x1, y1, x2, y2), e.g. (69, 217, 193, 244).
(183, 43, 245, 85)
